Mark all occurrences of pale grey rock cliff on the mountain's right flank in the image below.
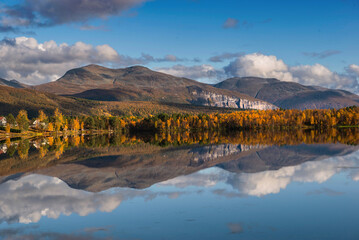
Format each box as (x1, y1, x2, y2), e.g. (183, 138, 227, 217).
(191, 89, 277, 110)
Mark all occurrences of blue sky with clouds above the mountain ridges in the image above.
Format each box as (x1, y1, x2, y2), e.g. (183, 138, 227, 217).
(0, 0, 359, 93)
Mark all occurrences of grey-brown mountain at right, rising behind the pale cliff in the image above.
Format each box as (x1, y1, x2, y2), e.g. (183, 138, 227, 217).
(214, 77, 359, 109)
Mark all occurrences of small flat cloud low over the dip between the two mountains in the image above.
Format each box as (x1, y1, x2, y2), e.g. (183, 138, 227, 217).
(156, 64, 223, 80)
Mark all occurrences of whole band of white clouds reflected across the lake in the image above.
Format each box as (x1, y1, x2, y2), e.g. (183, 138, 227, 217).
(0, 149, 359, 226)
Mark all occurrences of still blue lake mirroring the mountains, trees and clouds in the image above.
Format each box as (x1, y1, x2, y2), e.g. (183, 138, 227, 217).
(0, 128, 359, 240)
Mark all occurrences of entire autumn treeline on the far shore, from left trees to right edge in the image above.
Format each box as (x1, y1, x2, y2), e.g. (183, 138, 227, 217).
(2, 107, 359, 133)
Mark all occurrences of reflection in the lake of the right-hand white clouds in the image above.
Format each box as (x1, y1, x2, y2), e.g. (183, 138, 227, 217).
(160, 152, 359, 197)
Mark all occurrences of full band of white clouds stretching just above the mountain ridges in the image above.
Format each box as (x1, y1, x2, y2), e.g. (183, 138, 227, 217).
(0, 37, 359, 93)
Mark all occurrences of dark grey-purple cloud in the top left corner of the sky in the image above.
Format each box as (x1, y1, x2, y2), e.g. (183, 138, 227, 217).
(0, 0, 147, 32)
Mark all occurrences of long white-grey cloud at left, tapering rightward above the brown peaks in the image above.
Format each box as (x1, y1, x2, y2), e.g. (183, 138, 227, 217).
(0, 37, 190, 84)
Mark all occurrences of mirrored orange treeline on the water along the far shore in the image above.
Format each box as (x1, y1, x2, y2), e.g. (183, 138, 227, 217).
(0, 128, 359, 159)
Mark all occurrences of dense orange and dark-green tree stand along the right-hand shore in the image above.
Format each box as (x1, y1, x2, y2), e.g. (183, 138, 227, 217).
(130, 106, 359, 132)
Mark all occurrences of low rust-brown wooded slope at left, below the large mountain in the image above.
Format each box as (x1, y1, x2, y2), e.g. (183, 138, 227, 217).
(0, 86, 258, 118)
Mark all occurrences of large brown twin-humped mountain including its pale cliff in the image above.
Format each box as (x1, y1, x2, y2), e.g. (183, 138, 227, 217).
(33, 65, 276, 109)
